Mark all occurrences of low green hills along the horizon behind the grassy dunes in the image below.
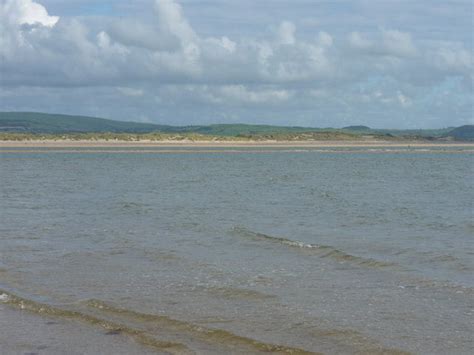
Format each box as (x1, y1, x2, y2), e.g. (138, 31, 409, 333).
(0, 112, 468, 140)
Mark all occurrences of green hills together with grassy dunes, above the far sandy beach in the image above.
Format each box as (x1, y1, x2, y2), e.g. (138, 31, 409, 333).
(0, 112, 474, 141)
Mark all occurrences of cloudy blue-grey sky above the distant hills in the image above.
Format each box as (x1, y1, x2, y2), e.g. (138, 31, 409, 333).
(0, 0, 474, 128)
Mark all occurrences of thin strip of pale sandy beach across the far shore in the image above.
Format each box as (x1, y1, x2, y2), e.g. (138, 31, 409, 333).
(0, 140, 474, 148)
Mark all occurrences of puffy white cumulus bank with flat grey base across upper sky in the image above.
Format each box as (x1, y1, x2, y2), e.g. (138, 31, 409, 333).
(0, 0, 466, 86)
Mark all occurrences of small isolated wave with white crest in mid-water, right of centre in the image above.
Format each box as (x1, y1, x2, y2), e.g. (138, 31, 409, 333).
(231, 227, 396, 268)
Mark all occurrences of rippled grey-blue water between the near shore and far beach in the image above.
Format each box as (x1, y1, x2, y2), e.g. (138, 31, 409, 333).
(0, 148, 474, 354)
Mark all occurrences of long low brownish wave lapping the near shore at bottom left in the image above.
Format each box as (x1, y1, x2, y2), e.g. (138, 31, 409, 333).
(0, 289, 317, 355)
